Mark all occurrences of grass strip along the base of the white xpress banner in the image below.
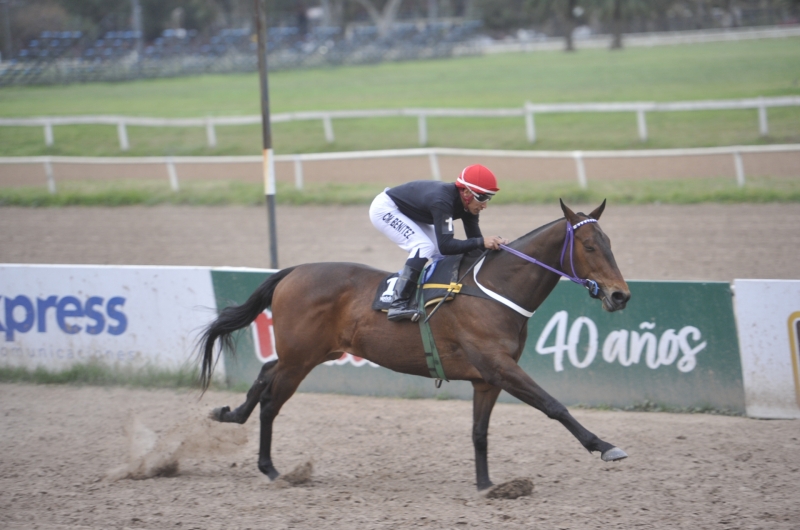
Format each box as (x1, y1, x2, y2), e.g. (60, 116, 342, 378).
(0, 362, 214, 388)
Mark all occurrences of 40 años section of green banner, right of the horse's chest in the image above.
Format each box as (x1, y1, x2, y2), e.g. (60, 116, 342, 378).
(520, 281, 744, 412)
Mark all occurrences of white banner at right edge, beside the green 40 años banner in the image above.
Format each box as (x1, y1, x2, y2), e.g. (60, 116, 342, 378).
(733, 280, 800, 418)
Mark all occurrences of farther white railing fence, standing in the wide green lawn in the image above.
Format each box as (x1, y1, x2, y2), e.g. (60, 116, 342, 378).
(0, 96, 800, 151)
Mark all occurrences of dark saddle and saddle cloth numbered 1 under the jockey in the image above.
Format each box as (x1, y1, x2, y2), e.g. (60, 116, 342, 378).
(372, 252, 488, 311)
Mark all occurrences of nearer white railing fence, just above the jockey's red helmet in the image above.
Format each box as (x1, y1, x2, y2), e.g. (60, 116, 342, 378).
(0, 144, 800, 193)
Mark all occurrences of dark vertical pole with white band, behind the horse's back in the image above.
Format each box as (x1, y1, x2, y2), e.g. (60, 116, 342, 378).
(260, 0, 278, 269)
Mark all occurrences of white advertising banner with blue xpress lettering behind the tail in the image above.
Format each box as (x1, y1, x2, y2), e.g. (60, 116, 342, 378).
(0, 264, 216, 369)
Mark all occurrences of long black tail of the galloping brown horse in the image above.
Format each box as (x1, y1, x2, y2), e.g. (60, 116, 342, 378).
(198, 267, 294, 392)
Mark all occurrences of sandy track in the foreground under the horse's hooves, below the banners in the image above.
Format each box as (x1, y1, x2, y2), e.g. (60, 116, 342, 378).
(0, 384, 800, 529)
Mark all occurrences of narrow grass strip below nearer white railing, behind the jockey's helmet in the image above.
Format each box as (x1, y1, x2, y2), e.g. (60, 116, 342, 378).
(0, 177, 800, 207)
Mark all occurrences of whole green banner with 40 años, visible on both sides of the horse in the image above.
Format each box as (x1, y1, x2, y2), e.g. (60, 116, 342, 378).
(212, 269, 745, 412)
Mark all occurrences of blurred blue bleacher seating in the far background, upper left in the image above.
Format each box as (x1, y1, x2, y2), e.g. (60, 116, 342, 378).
(0, 21, 480, 86)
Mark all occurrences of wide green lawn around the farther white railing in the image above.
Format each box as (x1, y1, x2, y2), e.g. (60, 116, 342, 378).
(0, 38, 800, 156)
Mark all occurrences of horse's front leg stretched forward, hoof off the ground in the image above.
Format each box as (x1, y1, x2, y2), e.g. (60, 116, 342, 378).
(476, 353, 628, 462)
